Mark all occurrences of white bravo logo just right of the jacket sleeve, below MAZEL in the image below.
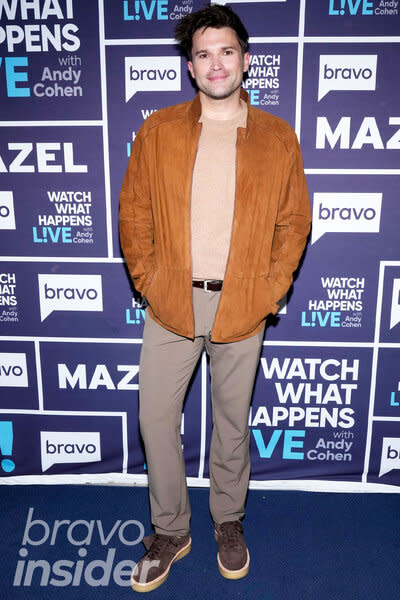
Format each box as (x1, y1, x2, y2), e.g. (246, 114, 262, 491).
(311, 193, 382, 244)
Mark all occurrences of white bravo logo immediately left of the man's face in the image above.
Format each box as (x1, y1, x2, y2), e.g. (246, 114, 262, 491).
(125, 56, 181, 102)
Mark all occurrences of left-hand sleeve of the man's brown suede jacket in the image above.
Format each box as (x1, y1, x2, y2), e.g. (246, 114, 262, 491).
(119, 131, 155, 295)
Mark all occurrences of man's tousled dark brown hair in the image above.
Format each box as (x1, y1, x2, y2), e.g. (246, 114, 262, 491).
(174, 4, 249, 60)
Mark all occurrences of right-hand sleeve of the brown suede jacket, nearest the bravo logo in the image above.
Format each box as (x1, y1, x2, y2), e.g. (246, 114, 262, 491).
(269, 130, 311, 312)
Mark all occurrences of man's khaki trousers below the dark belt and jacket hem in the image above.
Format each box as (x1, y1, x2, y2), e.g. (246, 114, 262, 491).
(139, 288, 264, 535)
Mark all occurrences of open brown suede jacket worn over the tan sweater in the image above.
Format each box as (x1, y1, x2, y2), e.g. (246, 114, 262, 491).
(120, 90, 311, 342)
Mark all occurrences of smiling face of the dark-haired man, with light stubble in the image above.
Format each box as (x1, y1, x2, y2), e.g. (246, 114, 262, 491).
(188, 27, 249, 100)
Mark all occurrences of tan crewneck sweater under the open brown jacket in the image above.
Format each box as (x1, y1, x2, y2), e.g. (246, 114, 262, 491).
(191, 100, 247, 279)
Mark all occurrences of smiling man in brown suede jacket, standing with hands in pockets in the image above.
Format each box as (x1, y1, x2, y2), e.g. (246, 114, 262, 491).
(120, 5, 310, 592)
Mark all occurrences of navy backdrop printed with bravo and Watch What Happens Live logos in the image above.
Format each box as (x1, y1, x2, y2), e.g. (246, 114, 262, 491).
(0, 0, 400, 491)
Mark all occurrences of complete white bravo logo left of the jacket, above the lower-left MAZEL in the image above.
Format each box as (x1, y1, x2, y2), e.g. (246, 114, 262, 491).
(38, 274, 103, 321)
